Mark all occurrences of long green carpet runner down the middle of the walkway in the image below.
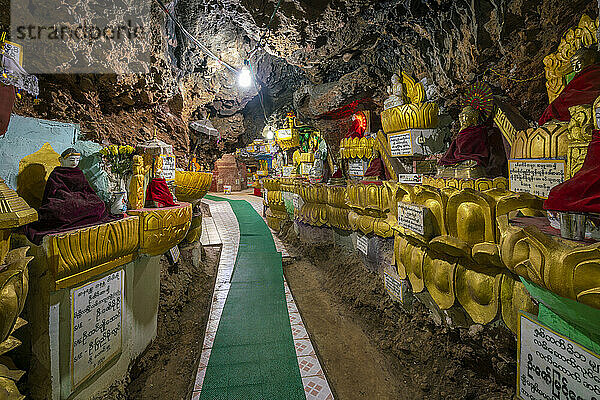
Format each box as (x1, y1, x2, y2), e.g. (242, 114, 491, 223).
(200, 196, 305, 400)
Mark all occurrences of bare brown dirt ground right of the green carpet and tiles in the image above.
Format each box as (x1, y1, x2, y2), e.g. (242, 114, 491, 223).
(284, 223, 516, 400)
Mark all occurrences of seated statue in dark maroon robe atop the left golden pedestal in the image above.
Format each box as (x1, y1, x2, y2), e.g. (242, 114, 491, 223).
(25, 148, 123, 245)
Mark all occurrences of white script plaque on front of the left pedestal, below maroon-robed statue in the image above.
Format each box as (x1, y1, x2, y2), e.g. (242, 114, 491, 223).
(71, 270, 125, 386)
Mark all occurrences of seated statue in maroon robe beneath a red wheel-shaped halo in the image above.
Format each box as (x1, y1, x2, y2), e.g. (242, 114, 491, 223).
(437, 106, 507, 179)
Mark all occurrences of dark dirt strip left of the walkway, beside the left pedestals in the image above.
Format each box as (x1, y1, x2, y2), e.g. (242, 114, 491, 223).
(118, 247, 220, 400)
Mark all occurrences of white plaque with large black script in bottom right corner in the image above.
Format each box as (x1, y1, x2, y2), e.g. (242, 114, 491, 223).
(517, 314, 600, 400)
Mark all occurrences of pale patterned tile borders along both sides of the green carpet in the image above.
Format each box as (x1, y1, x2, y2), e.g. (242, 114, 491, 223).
(192, 196, 333, 399)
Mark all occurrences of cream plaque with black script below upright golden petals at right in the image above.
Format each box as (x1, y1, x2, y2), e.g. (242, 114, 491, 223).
(508, 160, 565, 199)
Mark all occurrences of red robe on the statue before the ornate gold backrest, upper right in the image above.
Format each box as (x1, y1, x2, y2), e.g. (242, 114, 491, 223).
(538, 64, 600, 125)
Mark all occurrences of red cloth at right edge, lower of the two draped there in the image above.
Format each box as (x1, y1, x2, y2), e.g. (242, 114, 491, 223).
(544, 130, 600, 213)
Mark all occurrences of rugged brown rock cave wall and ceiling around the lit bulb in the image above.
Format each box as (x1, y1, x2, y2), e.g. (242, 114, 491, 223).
(2, 0, 598, 163)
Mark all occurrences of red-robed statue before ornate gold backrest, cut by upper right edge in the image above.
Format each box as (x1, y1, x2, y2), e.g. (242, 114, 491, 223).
(538, 47, 600, 126)
